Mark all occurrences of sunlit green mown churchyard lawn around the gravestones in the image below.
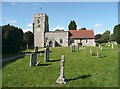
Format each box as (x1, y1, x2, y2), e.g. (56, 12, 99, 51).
(2, 46, 118, 87)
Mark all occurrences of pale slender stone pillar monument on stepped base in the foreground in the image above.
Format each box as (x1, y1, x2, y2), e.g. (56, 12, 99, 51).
(56, 55, 66, 84)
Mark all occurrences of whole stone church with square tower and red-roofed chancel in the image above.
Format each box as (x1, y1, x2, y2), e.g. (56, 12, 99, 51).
(33, 13, 95, 47)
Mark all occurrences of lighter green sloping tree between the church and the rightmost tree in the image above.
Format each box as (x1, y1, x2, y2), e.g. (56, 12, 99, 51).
(98, 30, 110, 43)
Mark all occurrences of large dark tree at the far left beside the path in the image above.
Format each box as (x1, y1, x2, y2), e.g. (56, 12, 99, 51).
(2, 24, 23, 54)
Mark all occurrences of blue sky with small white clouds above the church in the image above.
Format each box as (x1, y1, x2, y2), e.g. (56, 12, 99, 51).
(2, 2, 118, 34)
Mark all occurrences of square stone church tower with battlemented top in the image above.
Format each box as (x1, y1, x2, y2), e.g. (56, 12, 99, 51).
(33, 13, 49, 47)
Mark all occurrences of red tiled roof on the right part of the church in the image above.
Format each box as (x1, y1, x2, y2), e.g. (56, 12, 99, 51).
(69, 30, 95, 38)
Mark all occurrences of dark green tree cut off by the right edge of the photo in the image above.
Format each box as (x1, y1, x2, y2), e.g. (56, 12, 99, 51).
(113, 24, 120, 44)
